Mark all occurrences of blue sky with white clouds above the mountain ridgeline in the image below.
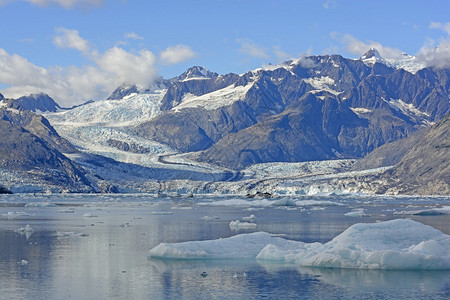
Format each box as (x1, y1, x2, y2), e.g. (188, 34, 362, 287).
(0, 0, 450, 107)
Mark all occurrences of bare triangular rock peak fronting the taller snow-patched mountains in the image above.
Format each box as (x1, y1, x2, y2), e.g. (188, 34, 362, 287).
(198, 94, 370, 169)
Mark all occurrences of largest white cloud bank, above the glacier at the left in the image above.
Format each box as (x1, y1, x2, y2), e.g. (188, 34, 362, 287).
(0, 27, 195, 107)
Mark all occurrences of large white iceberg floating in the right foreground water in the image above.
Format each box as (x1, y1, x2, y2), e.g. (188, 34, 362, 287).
(149, 219, 450, 270)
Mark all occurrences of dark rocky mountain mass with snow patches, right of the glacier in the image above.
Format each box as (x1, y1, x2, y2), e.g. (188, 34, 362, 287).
(136, 50, 450, 168)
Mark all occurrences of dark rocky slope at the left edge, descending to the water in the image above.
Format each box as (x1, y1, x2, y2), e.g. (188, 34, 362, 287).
(0, 101, 93, 191)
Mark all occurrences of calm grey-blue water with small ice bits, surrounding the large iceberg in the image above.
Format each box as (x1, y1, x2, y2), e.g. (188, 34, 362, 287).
(0, 195, 450, 299)
